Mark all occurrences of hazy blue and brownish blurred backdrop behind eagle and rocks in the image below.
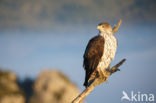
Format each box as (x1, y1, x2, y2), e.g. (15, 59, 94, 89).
(0, 0, 156, 103)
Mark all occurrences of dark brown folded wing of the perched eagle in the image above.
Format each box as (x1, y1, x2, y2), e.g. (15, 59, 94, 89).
(83, 35, 104, 86)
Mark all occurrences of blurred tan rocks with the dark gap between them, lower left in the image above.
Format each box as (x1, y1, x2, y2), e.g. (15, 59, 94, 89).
(0, 70, 79, 103)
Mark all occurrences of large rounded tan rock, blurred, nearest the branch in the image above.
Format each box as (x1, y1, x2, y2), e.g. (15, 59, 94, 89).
(29, 70, 79, 103)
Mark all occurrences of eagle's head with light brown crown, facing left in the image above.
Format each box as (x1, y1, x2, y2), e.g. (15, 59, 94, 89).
(97, 22, 112, 34)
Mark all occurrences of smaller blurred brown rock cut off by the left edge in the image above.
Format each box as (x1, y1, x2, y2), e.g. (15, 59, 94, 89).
(0, 70, 25, 103)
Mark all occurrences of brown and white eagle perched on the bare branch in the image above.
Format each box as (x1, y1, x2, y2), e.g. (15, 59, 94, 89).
(83, 22, 117, 88)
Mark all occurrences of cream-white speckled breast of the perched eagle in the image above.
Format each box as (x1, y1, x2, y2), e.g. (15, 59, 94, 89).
(97, 33, 117, 69)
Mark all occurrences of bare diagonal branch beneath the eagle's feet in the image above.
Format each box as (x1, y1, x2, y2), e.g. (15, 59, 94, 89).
(72, 59, 126, 103)
